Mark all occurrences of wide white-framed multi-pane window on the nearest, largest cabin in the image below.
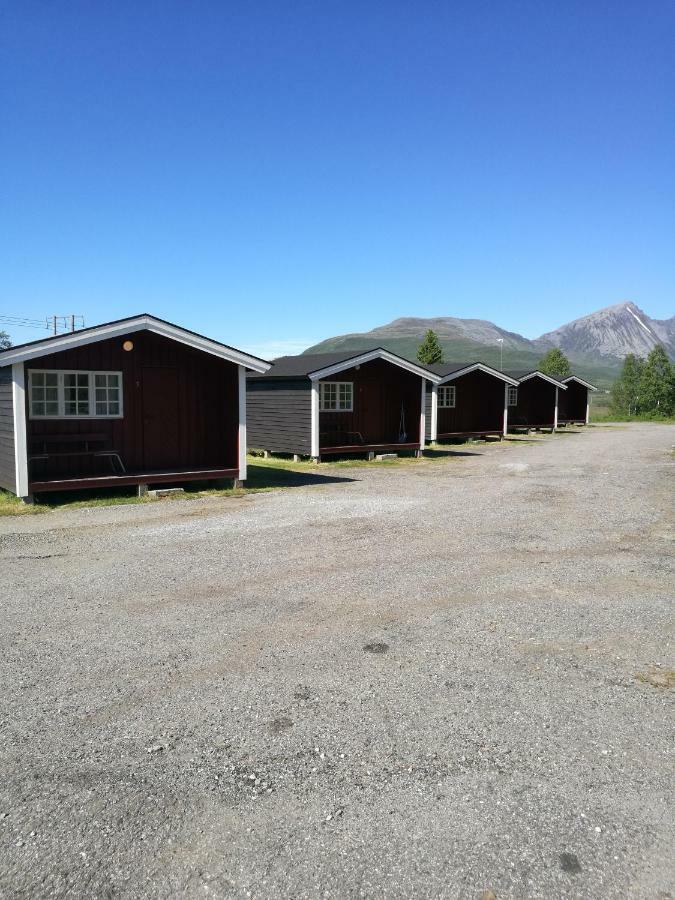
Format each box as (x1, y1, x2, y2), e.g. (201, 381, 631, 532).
(28, 370, 122, 419)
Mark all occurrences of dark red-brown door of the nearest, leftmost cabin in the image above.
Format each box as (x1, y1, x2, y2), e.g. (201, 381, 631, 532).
(143, 366, 180, 471)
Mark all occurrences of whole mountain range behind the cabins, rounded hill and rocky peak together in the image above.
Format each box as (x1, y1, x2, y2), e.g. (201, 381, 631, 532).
(305, 303, 675, 388)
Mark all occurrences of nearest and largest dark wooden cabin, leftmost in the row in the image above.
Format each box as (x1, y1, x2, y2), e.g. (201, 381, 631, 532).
(0, 315, 269, 497)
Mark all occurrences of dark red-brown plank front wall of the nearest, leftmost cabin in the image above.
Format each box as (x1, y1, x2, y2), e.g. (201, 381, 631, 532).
(26, 331, 239, 477)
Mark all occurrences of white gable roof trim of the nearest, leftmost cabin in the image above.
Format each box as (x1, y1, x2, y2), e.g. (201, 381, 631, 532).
(0, 315, 271, 373)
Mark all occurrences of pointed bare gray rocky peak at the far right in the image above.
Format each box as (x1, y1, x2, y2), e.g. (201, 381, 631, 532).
(539, 302, 675, 359)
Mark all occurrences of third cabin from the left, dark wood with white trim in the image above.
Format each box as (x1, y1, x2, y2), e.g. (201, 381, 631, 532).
(427, 362, 518, 442)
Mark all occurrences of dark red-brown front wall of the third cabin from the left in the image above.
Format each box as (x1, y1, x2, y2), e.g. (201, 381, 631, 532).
(437, 370, 504, 436)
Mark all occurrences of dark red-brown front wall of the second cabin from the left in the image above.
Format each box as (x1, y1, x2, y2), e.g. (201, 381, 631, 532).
(319, 359, 422, 446)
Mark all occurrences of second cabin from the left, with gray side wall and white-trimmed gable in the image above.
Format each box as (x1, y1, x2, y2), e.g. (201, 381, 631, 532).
(247, 347, 436, 459)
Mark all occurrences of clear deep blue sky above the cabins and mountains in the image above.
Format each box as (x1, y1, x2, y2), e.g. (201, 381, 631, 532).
(0, 0, 675, 356)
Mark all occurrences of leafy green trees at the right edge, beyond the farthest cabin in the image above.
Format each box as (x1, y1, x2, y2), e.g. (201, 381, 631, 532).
(610, 347, 675, 418)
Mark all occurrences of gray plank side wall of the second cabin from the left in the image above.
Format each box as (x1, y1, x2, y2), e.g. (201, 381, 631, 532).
(246, 378, 312, 456)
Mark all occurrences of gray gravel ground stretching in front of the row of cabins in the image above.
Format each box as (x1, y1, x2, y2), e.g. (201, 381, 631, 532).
(0, 425, 675, 900)
